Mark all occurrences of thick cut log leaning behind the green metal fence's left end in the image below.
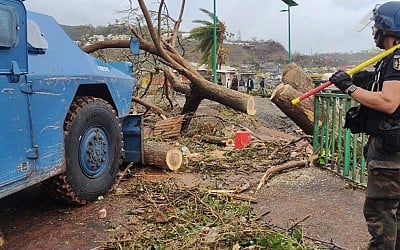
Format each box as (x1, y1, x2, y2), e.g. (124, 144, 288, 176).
(271, 84, 314, 135)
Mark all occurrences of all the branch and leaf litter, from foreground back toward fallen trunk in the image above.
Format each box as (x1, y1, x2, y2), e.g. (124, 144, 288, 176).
(104, 102, 341, 249)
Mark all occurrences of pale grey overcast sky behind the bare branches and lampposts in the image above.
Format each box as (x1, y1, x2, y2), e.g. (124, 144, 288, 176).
(25, 0, 384, 55)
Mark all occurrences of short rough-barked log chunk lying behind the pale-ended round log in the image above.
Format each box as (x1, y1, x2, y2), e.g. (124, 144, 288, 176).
(153, 115, 183, 139)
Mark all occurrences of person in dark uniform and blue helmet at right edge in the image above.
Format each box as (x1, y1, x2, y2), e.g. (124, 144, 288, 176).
(329, 1, 400, 250)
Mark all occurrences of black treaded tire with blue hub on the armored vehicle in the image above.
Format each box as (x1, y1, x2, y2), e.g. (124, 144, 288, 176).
(44, 97, 122, 204)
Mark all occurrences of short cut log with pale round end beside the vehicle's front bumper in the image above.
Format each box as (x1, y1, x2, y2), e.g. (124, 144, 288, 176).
(143, 141, 183, 171)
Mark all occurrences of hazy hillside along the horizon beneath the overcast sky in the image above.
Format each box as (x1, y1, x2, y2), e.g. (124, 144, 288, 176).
(62, 25, 378, 68)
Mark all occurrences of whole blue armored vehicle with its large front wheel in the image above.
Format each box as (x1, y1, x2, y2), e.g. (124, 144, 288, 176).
(0, 0, 141, 204)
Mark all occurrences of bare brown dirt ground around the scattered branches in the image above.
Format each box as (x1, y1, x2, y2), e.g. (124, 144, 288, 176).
(0, 97, 368, 249)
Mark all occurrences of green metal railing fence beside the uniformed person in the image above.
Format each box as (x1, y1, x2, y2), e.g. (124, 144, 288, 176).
(313, 91, 367, 186)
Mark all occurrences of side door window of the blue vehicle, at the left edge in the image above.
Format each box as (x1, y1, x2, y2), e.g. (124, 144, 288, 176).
(0, 5, 18, 48)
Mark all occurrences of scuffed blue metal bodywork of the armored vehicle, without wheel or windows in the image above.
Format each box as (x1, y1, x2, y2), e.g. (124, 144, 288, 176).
(0, 0, 136, 198)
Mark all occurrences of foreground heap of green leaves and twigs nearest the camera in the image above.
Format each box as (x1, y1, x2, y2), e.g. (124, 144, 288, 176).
(104, 181, 309, 249)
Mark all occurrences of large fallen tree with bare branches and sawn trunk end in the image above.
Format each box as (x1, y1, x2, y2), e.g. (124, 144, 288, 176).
(83, 0, 256, 128)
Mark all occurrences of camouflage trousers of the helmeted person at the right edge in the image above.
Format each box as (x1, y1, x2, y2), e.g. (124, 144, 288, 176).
(364, 131, 400, 250)
